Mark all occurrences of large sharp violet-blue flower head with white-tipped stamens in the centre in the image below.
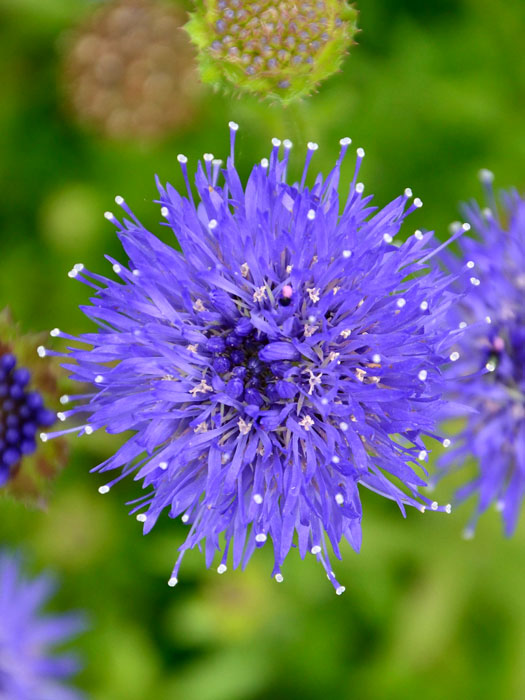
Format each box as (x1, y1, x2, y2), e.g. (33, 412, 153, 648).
(59, 123, 455, 592)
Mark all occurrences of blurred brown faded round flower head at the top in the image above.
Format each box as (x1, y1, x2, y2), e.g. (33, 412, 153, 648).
(63, 0, 199, 139)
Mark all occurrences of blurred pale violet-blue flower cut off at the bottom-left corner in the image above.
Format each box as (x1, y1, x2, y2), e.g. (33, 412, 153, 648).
(0, 550, 84, 700)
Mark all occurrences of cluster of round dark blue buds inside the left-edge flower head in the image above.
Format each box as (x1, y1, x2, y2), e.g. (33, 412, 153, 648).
(0, 353, 56, 486)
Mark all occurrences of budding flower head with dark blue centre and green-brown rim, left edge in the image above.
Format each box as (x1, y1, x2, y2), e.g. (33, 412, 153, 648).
(0, 309, 67, 502)
